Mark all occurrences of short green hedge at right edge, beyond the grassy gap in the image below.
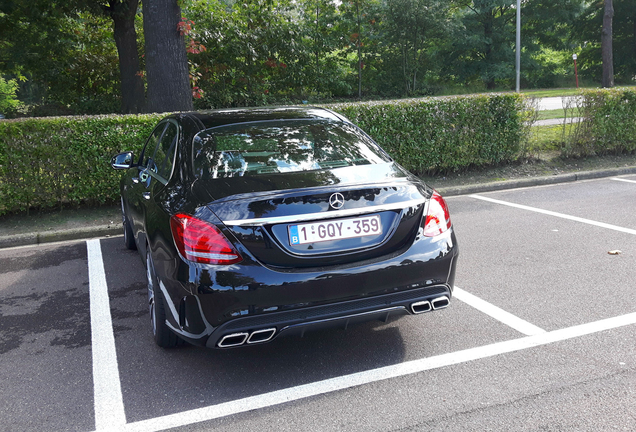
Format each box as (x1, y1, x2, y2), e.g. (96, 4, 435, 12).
(562, 88, 636, 156)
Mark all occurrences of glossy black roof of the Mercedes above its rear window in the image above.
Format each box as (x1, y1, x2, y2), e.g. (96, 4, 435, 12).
(179, 106, 348, 129)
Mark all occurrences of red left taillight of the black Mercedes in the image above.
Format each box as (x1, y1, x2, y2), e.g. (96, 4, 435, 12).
(170, 213, 243, 264)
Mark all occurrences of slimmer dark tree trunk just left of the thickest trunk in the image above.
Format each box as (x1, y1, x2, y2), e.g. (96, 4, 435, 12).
(107, 0, 145, 114)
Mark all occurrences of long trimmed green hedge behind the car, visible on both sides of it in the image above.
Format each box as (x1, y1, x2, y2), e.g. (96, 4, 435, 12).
(0, 94, 527, 214)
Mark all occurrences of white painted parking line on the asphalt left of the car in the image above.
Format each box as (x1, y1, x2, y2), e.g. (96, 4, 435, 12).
(86, 240, 126, 431)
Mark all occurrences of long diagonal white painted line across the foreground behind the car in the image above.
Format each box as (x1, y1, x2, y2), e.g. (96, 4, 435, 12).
(115, 313, 636, 432)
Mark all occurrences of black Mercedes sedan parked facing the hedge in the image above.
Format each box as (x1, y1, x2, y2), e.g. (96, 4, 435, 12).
(112, 107, 458, 348)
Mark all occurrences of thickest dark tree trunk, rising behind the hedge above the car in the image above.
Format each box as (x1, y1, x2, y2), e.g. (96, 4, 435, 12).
(142, 0, 192, 112)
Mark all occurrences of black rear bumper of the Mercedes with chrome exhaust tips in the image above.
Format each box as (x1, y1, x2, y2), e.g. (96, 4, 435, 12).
(159, 229, 459, 348)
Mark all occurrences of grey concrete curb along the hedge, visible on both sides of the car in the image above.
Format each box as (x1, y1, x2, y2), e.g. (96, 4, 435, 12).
(0, 167, 636, 249)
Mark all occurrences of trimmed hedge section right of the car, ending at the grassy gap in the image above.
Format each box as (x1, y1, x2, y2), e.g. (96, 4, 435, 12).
(328, 94, 529, 174)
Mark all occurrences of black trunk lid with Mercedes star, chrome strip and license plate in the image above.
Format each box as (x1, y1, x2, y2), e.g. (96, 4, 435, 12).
(193, 163, 430, 268)
